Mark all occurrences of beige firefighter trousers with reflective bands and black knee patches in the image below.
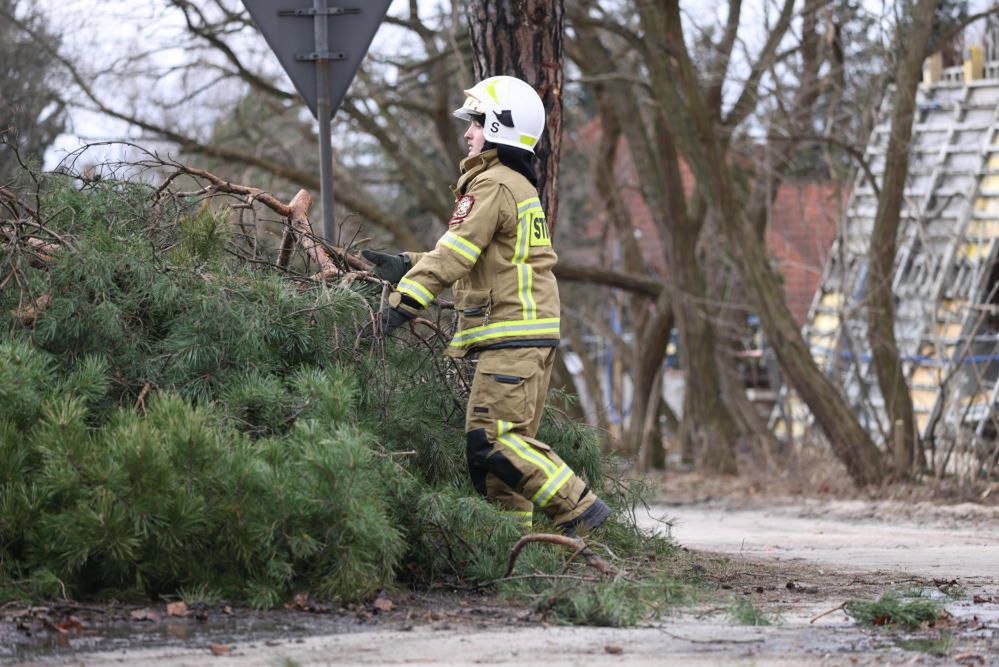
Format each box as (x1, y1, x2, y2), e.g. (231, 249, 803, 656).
(465, 347, 597, 527)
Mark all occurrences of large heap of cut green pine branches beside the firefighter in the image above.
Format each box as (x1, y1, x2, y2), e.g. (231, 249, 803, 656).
(0, 168, 683, 625)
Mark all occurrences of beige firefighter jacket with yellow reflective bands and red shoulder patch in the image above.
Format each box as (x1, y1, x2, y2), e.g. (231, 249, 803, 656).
(392, 150, 559, 357)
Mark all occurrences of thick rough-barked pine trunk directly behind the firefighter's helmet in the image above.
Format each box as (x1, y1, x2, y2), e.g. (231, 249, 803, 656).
(468, 0, 565, 234)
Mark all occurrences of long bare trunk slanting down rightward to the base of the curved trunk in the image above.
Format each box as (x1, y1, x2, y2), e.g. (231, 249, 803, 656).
(652, 0, 884, 485)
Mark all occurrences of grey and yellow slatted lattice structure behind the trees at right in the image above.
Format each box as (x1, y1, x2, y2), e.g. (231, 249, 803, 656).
(771, 48, 999, 478)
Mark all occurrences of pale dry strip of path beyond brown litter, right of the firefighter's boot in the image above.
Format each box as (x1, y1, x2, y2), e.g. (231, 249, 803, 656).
(646, 500, 999, 583)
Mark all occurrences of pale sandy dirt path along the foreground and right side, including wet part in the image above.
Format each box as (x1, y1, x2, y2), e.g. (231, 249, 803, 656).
(9, 500, 999, 667)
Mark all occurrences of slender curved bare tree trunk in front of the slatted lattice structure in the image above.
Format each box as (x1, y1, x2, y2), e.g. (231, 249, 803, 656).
(867, 0, 937, 475)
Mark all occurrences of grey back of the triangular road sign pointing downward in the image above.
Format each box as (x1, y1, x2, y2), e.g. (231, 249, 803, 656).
(243, 0, 392, 120)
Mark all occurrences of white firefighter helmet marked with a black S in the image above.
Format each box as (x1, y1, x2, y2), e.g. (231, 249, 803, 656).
(454, 76, 545, 153)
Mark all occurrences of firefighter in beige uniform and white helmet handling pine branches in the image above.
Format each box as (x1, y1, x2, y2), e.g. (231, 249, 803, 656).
(364, 76, 610, 535)
